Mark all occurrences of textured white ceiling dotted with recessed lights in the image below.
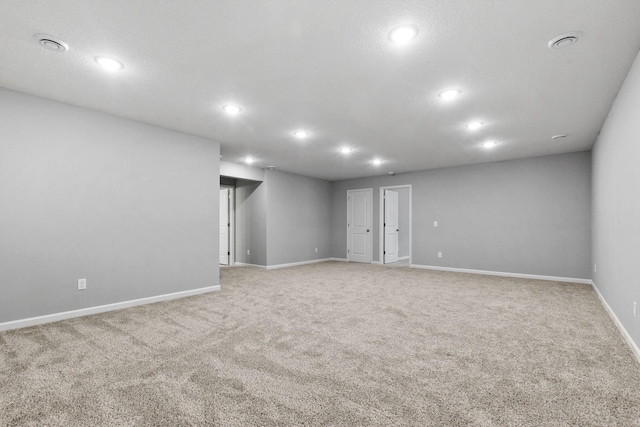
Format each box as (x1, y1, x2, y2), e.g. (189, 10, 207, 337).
(0, 0, 640, 180)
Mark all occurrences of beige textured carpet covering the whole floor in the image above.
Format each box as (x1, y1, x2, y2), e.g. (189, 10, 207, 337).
(0, 262, 640, 427)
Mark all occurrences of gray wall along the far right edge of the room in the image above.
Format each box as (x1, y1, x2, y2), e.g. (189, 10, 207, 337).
(593, 49, 640, 352)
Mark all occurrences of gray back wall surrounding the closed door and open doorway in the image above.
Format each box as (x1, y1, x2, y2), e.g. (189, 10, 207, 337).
(332, 152, 591, 279)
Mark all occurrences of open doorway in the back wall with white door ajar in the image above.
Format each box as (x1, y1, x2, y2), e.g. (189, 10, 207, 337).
(379, 184, 412, 267)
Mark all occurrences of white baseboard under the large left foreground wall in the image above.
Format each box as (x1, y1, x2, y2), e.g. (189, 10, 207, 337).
(0, 285, 220, 331)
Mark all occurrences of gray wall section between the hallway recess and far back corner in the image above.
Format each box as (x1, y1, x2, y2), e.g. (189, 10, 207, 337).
(265, 170, 331, 266)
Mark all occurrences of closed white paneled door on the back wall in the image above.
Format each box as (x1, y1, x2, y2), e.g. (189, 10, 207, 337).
(347, 189, 373, 263)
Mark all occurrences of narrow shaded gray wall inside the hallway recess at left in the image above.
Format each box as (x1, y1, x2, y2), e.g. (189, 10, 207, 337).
(235, 179, 267, 266)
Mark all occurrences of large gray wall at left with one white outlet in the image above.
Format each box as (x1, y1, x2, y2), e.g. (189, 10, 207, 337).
(0, 89, 220, 323)
